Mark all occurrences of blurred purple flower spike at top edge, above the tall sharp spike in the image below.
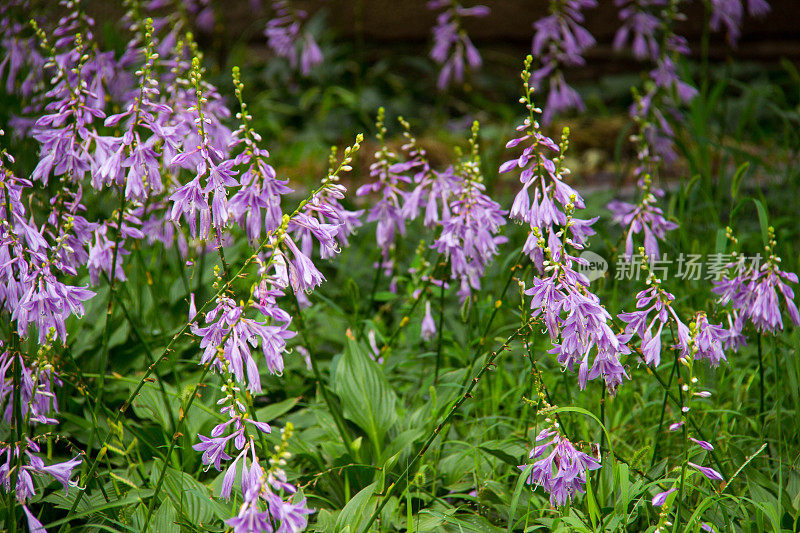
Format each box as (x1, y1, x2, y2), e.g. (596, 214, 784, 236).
(531, 0, 597, 124)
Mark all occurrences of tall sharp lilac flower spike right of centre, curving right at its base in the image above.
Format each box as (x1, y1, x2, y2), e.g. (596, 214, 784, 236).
(500, 56, 630, 394)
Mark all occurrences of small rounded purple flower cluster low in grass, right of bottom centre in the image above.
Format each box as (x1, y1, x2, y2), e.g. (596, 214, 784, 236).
(519, 428, 600, 507)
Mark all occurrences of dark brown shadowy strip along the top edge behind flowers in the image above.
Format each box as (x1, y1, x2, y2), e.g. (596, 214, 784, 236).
(89, 0, 800, 64)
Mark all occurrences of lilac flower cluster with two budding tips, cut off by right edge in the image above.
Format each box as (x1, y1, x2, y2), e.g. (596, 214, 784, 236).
(712, 226, 800, 336)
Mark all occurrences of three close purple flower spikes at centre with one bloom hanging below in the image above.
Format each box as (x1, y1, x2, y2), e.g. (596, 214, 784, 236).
(356, 108, 507, 320)
